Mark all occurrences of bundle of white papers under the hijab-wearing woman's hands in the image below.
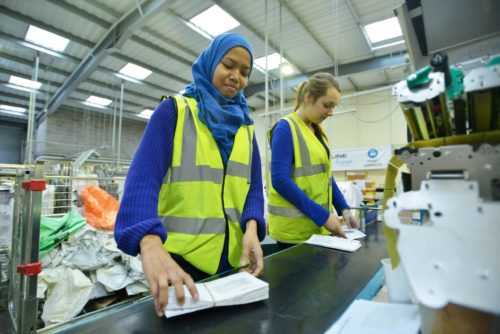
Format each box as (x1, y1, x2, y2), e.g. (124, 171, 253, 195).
(165, 272, 269, 318)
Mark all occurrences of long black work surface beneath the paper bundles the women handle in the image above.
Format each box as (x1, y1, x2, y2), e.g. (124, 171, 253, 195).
(44, 223, 386, 334)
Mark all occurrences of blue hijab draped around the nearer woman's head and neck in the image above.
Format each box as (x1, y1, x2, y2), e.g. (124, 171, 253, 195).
(183, 33, 253, 166)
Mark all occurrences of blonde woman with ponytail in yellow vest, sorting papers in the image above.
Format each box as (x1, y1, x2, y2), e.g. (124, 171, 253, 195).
(268, 73, 358, 249)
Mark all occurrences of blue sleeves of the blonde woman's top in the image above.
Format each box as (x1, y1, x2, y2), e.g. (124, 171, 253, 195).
(271, 120, 349, 226)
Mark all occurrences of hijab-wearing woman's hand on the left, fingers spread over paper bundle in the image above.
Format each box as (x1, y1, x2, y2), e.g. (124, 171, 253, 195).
(140, 235, 199, 317)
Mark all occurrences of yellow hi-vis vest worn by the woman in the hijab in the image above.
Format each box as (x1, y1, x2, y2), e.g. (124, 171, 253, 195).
(158, 96, 254, 275)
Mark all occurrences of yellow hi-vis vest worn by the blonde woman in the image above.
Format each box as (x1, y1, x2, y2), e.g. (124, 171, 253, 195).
(268, 113, 332, 243)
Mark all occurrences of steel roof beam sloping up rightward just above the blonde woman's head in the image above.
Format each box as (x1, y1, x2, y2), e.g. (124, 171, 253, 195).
(245, 52, 407, 97)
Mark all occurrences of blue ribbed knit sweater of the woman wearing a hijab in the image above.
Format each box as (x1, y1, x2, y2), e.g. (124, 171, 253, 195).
(115, 99, 266, 271)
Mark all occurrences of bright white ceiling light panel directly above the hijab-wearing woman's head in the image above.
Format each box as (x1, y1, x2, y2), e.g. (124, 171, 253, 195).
(189, 5, 240, 36)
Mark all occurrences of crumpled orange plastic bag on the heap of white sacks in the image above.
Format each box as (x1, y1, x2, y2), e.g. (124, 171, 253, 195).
(82, 186, 120, 230)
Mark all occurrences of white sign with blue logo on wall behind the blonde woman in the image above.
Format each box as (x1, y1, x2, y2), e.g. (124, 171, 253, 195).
(332, 145, 392, 171)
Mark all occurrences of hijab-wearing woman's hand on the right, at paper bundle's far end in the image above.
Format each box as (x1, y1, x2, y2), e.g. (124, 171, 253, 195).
(240, 219, 264, 276)
